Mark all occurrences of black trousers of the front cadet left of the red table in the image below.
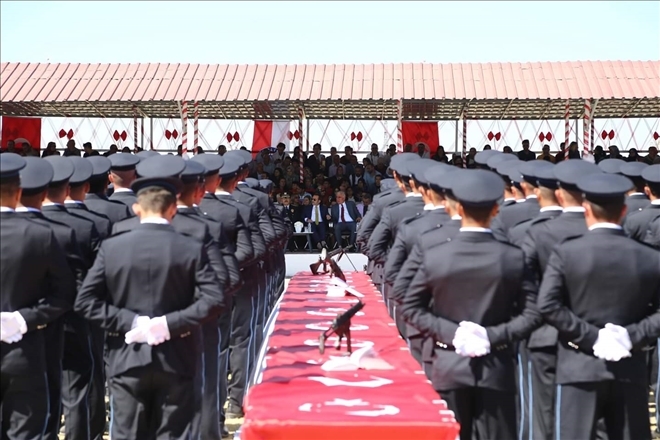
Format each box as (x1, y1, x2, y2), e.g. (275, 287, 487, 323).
(108, 364, 196, 440)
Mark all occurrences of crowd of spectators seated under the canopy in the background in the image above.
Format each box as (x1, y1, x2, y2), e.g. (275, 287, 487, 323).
(5, 139, 660, 251)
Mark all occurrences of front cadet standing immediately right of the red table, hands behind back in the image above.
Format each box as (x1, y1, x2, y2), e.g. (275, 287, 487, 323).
(402, 170, 541, 440)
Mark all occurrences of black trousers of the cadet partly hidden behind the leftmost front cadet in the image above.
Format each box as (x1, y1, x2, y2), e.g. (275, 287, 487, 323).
(43, 318, 64, 440)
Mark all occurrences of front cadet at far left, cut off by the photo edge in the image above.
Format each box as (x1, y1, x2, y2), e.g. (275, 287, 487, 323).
(0, 153, 76, 439)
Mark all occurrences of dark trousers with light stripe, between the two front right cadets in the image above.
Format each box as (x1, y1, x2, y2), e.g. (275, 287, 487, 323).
(526, 347, 557, 440)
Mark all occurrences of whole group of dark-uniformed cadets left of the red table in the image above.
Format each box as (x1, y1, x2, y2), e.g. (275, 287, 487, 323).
(0, 152, 292, 440)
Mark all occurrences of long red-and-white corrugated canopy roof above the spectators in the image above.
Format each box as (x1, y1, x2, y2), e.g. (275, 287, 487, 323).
(0, 61, 660, 120)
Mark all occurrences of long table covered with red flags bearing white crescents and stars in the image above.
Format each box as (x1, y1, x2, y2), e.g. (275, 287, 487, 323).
(240, 272, 459, 440)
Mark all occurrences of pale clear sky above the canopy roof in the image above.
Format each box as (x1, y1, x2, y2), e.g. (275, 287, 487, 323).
(0, 0, 660, 64)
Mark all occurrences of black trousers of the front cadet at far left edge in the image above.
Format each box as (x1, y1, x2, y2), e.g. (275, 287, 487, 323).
(0, 371, 49, 440)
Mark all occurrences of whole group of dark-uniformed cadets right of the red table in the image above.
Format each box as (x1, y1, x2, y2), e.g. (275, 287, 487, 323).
(358, 151, 660, 440)
